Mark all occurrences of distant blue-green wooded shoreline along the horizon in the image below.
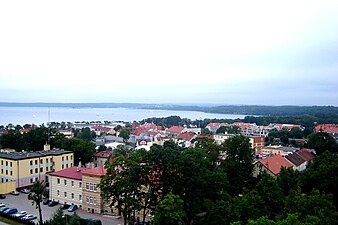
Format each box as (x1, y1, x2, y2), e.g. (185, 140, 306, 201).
(0, 102, 338, 116)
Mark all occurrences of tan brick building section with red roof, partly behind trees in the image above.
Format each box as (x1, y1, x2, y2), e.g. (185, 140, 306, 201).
(82, 166, 110, 213)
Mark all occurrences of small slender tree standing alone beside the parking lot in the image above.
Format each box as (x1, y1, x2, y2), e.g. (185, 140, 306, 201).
(28, 180, 47, 225)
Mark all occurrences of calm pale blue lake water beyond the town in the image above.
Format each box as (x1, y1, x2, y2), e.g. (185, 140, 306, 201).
(0, 107, 246, 125)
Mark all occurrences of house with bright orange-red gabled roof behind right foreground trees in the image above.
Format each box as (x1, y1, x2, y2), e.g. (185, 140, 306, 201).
(253, 155, 294, 177)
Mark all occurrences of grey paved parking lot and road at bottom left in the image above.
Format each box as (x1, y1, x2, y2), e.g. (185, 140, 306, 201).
(0, 193, 123, 225)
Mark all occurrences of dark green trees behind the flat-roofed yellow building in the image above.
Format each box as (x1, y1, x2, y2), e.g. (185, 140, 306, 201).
(0, 127, 96, 165)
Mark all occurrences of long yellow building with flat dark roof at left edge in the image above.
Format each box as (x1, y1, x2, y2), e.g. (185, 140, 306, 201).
(0, 148, 74, 189)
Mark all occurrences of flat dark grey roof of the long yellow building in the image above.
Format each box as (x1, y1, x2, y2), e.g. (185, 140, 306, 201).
(0, 150, 72, 160)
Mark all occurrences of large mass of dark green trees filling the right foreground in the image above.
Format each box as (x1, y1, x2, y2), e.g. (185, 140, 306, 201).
(99, 136, 338, 225)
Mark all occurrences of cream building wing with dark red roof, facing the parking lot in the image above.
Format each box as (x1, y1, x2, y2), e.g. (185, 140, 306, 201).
(49, 166, 87, 208)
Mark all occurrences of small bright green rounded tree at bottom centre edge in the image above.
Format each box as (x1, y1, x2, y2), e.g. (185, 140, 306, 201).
(153, 193, 185, 225)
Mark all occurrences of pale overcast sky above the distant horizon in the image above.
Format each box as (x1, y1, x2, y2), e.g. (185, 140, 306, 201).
(0, 0, 338, 105)
